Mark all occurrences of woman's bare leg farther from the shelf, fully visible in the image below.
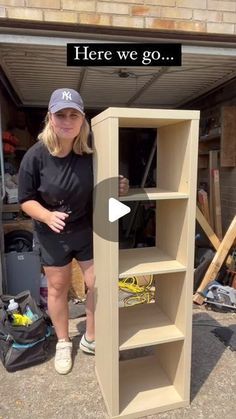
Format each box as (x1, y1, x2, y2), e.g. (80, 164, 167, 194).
(44, 263, 71, 341)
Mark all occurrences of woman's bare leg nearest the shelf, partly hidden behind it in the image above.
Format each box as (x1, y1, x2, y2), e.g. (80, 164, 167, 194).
(79, 259, 95, 341)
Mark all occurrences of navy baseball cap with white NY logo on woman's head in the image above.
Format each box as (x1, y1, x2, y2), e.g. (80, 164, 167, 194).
(48, 88, 84, 115)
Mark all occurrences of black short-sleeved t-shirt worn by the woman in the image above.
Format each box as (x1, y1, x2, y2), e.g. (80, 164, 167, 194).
(18, 141, 93, 231)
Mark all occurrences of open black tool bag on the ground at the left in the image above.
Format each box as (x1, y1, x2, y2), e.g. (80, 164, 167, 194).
(0, 291, 51, 372)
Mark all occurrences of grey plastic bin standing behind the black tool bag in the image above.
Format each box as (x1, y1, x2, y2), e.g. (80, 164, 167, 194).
(5, 251, 41, 303)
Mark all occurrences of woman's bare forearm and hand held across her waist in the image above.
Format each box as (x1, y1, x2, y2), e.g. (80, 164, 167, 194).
(21, 199, 69, 233)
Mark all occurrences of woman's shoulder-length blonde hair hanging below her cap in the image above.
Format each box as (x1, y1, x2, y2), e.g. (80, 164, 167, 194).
(38, 112, 93, 156)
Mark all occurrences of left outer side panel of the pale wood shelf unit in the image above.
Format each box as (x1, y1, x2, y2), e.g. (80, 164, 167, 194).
(93, 118, 119, 416)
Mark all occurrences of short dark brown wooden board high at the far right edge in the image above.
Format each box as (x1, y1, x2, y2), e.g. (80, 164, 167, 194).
(220, 106, 236, 167)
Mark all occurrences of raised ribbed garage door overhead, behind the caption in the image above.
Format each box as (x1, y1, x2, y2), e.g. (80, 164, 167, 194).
(0, 34, 236, 110)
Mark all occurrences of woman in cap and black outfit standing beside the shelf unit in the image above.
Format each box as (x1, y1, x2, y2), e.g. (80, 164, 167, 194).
(19, 89, 128, 374)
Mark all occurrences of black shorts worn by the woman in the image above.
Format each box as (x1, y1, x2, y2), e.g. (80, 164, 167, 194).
(34, 225, 93, 266)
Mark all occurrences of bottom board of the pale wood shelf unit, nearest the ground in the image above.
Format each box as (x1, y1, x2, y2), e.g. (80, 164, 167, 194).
(120, 354, 185, 418)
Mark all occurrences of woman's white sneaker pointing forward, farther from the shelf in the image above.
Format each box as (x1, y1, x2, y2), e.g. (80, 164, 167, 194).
(54, 341, 72, 374)
